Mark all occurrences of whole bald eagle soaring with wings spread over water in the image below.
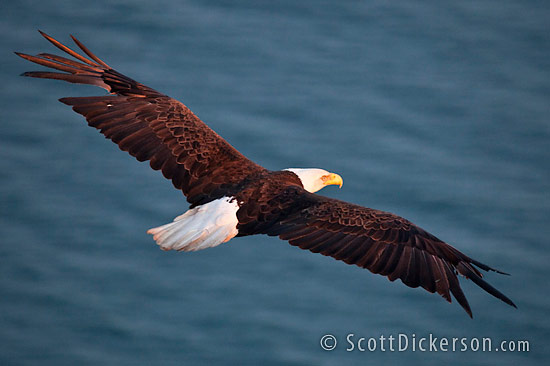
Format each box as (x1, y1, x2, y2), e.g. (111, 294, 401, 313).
(16, 32, 516, 317)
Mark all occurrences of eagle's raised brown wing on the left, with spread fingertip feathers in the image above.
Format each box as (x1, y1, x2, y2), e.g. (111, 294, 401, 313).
(16, 32, 264, 206)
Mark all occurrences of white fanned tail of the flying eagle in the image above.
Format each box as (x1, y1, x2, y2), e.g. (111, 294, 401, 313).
(147, 197, 239, 251)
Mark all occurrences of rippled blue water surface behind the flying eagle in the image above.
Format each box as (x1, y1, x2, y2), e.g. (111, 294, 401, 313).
(0, 0, 550, 365)
